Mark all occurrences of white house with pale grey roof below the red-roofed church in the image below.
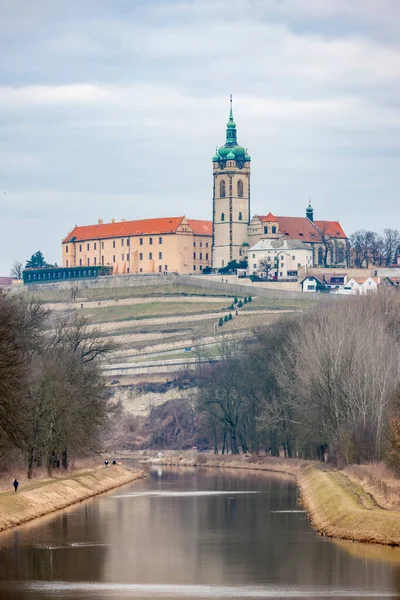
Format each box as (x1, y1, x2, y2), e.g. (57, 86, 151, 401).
(248, 238, 313, 281)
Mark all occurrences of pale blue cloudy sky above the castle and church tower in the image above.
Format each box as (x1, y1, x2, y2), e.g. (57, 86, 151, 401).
(0, 0, 400, 275)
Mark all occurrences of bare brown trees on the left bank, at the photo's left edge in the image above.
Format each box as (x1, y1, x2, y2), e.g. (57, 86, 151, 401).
(0, 293, 114, 478)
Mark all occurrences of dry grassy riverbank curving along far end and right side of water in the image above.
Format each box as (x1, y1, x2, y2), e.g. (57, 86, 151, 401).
(130, 452, 400, 546)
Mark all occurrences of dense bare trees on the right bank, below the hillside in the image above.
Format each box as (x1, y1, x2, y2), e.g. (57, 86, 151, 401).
(196, 292, 400, 464)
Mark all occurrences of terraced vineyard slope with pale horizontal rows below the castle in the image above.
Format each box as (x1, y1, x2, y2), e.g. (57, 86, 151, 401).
(23, 281, 310, 410)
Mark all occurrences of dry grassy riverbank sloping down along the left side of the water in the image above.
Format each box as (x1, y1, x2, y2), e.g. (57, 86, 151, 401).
(0, 465, 144, 531)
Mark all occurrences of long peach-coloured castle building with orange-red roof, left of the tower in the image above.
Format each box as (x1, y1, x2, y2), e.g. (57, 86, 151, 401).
(62, 216, 212, 275)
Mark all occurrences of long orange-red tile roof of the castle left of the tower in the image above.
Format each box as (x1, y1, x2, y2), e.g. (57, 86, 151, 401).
(63, 217, 189, 242)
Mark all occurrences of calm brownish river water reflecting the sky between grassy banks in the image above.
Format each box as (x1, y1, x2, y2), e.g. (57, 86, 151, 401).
(0, 468, 400, 600)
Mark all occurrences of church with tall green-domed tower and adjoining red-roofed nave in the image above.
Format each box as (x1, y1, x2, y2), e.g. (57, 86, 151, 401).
(212, 101, 349, 271)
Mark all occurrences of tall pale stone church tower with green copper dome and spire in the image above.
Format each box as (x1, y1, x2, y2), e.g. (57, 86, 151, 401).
(212, 96, 251, 269)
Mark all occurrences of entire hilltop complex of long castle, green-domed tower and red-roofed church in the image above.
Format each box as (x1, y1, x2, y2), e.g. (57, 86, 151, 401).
(62, 96, 348, 275)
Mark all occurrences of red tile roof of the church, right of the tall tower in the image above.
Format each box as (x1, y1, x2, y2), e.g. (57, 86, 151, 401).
(258, 213, 346, 242)
